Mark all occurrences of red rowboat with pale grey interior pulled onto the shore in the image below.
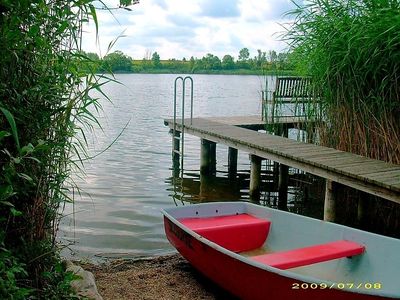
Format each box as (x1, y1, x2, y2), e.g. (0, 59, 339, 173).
(163, 202, 400, 300)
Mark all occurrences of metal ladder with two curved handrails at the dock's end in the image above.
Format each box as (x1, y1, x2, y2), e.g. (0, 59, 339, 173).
(172, 76, 193, 175)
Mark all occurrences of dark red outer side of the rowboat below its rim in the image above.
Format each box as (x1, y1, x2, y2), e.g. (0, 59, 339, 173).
(164, 211, 389, 300)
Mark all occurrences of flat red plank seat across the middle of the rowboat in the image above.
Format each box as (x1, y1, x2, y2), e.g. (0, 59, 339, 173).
(252, 240, 365, 270)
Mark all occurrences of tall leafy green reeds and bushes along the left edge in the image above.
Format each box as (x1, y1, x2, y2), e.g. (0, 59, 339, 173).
(0, 0, 113, 299)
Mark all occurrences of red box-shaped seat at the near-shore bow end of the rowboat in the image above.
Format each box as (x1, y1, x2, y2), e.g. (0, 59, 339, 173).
(179, 214, 271, 252)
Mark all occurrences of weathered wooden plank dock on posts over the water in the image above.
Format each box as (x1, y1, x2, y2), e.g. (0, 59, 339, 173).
(164, 116, 400, 220)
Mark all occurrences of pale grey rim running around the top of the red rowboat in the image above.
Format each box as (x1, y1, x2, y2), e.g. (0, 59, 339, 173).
(161, 201, 400, 299)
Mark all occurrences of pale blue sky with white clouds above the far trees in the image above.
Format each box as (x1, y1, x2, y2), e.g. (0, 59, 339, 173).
(83, 0, 294, 59)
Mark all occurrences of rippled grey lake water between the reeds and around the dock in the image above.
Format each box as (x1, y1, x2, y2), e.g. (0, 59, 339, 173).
(59, 74, 322, 259)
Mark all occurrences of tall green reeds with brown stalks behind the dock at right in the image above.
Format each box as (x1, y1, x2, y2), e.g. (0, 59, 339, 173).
(286, 0, 400, 235)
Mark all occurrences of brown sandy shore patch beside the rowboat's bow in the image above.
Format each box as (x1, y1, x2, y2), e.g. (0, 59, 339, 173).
(81, 254, 238, 300)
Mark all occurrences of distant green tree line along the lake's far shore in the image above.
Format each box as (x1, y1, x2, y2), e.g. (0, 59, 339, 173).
(83, 48, 294, 74)
